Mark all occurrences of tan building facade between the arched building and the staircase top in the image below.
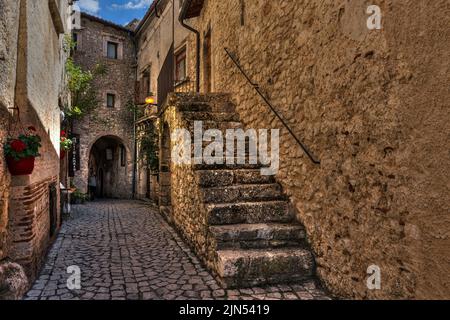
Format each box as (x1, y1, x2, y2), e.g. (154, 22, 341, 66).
(135, 0, 193, 200)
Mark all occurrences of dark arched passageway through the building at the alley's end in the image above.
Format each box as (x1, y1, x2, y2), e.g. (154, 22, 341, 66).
(88, 136, 132, 199)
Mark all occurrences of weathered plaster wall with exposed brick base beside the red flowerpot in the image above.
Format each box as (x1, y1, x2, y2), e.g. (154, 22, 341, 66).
(9, 1, 67, 280)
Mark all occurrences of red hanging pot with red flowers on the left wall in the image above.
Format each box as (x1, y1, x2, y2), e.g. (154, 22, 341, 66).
(3, 127, 41, 176)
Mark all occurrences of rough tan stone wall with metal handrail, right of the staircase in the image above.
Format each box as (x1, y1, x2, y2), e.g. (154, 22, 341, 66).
(185, 0, 450, 299)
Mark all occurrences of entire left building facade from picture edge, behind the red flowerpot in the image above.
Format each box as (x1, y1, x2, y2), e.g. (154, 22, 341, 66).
(0, 0, 70, 288)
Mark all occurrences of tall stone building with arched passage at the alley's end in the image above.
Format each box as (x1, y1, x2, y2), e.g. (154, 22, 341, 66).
(72, 13, 136, 198)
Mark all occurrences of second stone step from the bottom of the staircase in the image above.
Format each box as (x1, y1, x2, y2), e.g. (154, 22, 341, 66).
(209, 223, 306, 250)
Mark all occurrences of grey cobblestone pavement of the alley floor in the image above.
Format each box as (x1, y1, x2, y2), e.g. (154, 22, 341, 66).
(25, 201, 328, 300)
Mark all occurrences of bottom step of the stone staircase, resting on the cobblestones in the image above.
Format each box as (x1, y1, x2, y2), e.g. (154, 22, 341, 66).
(216, 248, 315, 288)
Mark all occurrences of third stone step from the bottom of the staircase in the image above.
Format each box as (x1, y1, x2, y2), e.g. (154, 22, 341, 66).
(206, 201, 294, 226)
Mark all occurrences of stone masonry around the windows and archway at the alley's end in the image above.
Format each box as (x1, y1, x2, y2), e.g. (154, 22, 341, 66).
(73, 15, 136, 198)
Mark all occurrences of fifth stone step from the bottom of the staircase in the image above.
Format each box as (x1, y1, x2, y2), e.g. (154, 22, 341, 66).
(196, 169, 275, 187)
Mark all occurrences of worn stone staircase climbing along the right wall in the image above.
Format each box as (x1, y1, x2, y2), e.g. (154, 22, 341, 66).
(172, 94, 315, 288)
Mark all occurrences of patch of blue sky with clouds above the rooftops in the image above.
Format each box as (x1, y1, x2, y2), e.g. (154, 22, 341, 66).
(76, 0, 153, 25)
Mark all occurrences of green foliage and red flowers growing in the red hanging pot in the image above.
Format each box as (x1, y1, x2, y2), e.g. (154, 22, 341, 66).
(3, 127, 41, 160)
